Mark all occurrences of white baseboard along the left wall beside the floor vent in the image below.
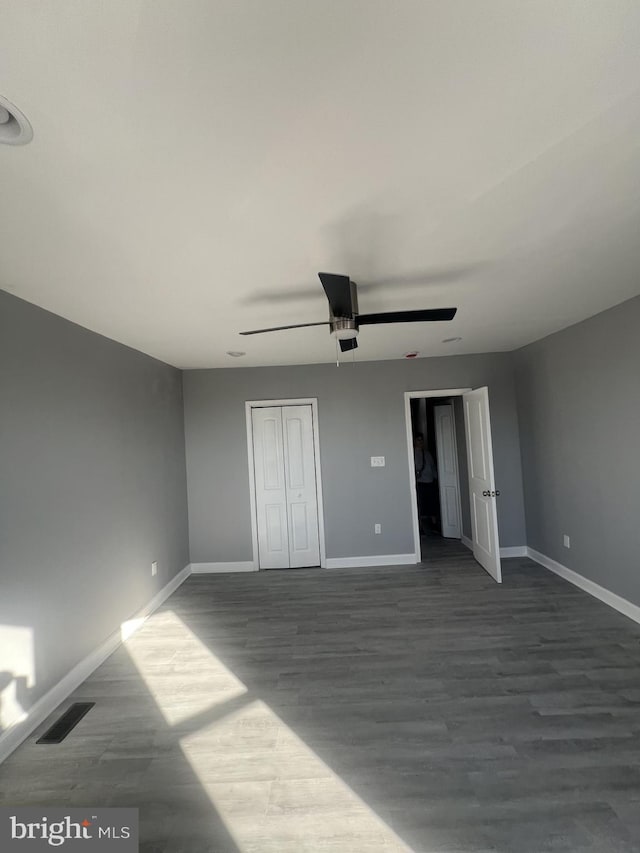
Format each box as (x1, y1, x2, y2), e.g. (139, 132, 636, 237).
(0, 566, 191, 764)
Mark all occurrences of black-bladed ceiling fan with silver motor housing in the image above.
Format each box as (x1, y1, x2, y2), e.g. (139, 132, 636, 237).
(240, 272, 458, 352)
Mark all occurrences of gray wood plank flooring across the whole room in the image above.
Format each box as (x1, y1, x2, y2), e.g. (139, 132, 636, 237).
(0, 537, 640, 853)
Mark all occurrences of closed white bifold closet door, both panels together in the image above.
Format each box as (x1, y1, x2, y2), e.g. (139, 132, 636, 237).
(251, 405, 320, 569)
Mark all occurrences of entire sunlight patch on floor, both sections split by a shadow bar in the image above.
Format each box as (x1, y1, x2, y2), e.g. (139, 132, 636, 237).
(126, 611, 410, 853)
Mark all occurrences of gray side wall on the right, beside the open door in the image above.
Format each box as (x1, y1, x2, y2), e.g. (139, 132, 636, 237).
(514, 297, 640, 604)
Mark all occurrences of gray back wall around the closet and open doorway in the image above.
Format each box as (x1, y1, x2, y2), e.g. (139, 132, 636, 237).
(184, 353, 525, 562)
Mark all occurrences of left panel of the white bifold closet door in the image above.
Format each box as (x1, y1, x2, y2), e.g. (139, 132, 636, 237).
(251, 406, 289, 569)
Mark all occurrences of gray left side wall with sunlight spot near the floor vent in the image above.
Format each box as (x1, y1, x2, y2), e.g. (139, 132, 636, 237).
(0, 291, 189, 728)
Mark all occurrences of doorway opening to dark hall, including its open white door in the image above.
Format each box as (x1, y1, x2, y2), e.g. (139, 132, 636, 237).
(405, 387, 502, 583)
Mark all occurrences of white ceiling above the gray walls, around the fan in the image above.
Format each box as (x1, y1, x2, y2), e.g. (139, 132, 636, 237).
(0, 0, 640, 367)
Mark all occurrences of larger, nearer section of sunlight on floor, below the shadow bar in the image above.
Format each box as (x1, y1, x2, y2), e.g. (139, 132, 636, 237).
(181, 700, 409, 853)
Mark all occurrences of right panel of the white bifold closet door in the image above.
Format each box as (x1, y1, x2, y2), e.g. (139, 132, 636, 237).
(282, 406, 320, 568)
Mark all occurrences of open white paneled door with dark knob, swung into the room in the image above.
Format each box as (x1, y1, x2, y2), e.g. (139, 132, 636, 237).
(462, 387, 502, 583)
